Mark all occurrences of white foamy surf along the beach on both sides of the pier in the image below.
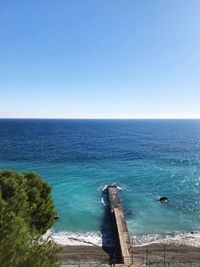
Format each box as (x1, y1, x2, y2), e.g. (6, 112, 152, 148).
(44, 230, 200, 247)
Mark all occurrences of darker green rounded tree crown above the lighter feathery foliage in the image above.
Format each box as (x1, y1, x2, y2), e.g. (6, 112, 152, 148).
(0, 171, 55, 233)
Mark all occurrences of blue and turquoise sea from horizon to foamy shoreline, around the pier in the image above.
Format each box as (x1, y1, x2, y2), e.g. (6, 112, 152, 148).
(0, 119, 200, 246)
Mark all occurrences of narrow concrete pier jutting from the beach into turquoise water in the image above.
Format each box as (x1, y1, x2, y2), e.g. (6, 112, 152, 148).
(107, 186, 131, 264)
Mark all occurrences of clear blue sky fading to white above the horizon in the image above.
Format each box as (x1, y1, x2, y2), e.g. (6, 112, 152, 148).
(0, 0, 200, 118)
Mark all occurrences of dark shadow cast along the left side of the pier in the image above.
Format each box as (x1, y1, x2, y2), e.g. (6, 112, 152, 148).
(101, 189, 122, 264)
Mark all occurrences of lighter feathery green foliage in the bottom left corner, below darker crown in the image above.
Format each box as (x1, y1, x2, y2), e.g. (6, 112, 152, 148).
(0, 216, 60, 267)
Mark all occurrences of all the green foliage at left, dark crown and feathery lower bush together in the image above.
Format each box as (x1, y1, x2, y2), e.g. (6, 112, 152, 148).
(0, 171, 60, 267)
